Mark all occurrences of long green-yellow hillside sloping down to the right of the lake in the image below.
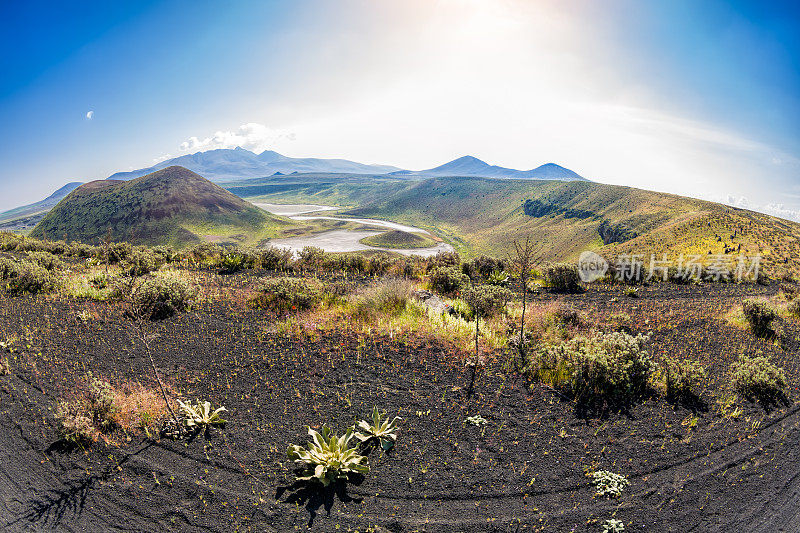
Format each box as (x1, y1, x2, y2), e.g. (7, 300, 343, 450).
(232, 175, 800, 271)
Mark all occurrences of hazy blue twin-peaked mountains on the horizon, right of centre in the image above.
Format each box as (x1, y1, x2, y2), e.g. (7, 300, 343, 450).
(392, 155, 586, 181)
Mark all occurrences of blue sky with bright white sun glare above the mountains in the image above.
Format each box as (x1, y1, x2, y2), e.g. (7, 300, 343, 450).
(0, 0, 800, 218)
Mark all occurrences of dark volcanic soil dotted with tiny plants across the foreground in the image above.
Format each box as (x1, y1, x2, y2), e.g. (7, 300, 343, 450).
(0, 282, 800, 532)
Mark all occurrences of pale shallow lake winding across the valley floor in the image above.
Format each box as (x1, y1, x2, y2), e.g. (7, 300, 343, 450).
(254, 203, 453, 257)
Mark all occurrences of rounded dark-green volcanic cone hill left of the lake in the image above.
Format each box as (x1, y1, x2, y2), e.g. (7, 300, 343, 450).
(31, 166, 298, 246)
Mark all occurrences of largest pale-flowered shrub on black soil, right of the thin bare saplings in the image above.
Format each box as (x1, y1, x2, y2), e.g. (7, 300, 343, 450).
(525, 332, 658, 400)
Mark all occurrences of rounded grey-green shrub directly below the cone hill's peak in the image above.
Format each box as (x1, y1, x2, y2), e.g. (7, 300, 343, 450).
(131, 275, 197, 320)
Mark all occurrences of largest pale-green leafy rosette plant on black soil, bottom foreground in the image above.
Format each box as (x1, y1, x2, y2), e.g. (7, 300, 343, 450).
(286, 425, 369, 487)
